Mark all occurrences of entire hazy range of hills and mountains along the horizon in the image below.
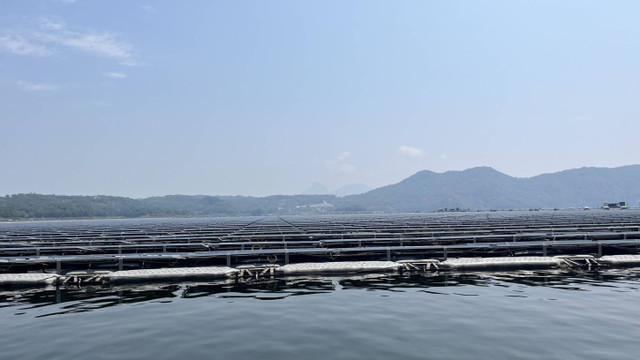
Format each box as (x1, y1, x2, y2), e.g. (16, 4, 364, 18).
(0, 165, 640, 219)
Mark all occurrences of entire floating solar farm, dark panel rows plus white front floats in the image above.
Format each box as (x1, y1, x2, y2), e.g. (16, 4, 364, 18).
(0, 210, 640, 283)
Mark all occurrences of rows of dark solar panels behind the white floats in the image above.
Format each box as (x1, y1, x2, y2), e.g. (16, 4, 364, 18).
(0, 210, 640, 272)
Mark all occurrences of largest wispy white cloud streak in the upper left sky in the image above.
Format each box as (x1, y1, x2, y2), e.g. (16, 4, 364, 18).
(36, 30, 136, 66)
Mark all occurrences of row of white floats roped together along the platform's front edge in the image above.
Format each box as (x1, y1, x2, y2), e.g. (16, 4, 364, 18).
(0, 255, 640, 287)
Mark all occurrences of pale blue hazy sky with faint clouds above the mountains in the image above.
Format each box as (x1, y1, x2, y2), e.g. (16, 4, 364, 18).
(0, 0, 640, 198)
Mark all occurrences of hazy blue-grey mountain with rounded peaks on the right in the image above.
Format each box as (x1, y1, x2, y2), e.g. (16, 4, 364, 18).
(345, 165, 640, 212)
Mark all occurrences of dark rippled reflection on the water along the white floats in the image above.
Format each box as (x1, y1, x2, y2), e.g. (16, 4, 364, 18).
(0, 268, 640, 317)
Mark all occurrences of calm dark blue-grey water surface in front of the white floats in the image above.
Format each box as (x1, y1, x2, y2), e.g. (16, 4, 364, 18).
(0, 269, 640, 360)
